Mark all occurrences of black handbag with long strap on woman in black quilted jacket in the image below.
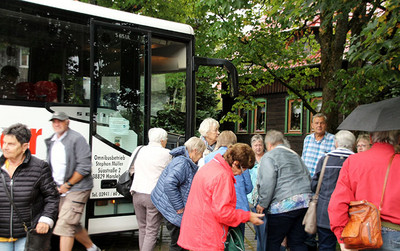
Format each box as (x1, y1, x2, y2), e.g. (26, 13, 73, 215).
(1, 172, 52, 251)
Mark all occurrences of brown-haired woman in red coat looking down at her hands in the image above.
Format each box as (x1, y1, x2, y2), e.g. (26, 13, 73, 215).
(178, 143, 263, 251)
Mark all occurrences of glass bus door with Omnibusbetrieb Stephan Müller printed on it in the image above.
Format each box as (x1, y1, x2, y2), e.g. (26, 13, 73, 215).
(87, 20, 147, 234)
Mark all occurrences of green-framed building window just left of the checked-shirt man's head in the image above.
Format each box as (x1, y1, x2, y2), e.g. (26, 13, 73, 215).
(285, 98, 303, 135)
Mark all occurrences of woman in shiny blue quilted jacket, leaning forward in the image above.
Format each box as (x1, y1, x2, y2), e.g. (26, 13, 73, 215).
(151, 137, 206, 251)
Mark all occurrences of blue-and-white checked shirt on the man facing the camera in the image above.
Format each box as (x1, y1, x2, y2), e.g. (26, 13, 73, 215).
(301, 132, 335, 177)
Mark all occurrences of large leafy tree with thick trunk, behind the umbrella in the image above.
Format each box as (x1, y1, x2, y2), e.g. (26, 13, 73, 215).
(244, 0, 399, 131)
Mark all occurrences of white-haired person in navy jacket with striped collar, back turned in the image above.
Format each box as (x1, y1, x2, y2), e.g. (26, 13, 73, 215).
(311, 130, 356, 251)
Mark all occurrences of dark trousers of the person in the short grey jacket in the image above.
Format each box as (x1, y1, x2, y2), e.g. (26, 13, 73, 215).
(267, 208, 307, 251)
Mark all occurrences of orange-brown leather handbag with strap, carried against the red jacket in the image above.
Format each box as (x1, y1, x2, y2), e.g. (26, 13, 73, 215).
(342, 154, 395, 250)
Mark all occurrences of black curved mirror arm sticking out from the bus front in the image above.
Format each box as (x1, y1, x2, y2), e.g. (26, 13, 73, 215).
(194, 57, 239, 97)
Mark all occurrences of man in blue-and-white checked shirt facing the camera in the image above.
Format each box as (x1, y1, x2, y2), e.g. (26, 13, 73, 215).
(301, 113, 335, 177)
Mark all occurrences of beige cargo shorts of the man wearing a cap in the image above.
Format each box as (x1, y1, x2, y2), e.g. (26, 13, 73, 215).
(53, 190, 90, 237)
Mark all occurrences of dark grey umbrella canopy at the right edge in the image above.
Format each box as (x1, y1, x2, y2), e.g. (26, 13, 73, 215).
(338, 97, 400, 132)
